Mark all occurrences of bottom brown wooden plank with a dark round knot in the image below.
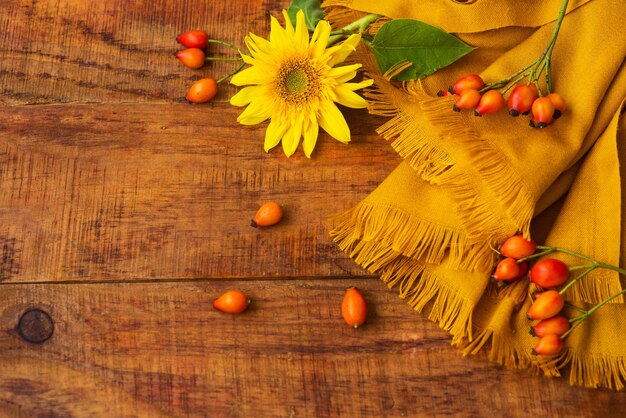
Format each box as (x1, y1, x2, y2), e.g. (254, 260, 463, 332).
(0, 279, 626, 417)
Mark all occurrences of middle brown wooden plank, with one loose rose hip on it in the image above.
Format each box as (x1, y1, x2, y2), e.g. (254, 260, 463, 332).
(0, 104, 399, 281)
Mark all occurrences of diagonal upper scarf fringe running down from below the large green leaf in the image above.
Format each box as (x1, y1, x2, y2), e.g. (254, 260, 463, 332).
(366, 76, 534, 240)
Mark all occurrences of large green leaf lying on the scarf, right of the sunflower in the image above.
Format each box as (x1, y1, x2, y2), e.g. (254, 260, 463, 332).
(370, 19, 474, 81)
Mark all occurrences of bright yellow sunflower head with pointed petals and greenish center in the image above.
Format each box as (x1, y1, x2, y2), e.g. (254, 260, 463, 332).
(230, 10, 372, 158)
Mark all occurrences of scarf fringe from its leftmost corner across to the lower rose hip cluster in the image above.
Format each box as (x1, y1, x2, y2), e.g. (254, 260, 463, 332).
(330, 201, 496, 271)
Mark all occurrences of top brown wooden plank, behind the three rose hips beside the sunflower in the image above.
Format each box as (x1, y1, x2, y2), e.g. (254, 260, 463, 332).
(0, 0, 289, 104)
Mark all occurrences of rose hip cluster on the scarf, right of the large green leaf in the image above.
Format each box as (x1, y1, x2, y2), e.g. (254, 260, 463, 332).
(437, 74, 565, 128)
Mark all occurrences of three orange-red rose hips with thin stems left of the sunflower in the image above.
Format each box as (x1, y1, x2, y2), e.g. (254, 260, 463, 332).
(176, 30, 243, 103)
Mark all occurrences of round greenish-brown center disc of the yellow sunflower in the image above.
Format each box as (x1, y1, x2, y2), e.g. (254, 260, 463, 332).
(275, 57, 322, 104)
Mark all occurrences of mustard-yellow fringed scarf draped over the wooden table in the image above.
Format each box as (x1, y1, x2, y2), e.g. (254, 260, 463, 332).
(324, 0, 626, 389)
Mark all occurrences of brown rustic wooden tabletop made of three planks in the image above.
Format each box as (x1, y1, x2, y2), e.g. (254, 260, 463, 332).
(0, 0, 626, 417)
